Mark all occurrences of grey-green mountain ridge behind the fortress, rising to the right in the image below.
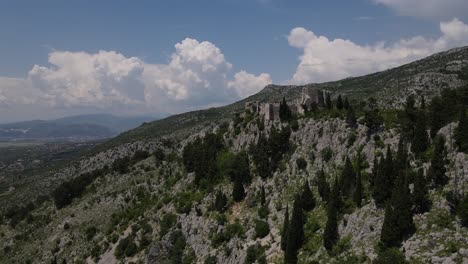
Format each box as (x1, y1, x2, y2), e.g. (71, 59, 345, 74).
(98, 46, 468, 150)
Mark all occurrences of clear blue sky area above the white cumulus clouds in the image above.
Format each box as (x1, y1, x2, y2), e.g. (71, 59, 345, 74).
(0, 0, 438, 82)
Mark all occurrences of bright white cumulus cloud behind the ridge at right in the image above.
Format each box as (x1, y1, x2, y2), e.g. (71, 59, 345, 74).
(288, 19, 468, 84)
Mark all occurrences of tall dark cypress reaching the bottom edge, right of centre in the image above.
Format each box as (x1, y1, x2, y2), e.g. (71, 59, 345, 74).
(284, 195, 304, 264)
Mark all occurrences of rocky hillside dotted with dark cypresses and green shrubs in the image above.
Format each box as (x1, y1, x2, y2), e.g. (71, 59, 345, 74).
(0, 48, 468, 263)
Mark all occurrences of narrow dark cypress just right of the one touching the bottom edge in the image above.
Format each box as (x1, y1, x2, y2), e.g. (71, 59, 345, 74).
(323, 180, 340, 251)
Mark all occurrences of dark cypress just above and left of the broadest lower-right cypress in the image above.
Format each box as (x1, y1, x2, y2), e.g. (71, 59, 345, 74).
(372, 146, 394, 207)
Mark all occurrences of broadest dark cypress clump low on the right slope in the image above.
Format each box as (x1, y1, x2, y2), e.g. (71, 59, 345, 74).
(380, 172, 416, 248)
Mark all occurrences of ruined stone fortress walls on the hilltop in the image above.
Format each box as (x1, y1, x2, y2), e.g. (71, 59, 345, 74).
(245, 87, 325, 121)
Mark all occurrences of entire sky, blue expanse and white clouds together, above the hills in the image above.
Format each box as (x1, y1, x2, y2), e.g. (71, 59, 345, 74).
(0, 0, 468, 122)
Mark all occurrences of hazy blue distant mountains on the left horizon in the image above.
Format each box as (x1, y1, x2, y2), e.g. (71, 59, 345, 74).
(0, 114, 157, 140)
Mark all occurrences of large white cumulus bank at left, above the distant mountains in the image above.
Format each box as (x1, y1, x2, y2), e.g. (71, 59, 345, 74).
(0, 38, 271, 118)
